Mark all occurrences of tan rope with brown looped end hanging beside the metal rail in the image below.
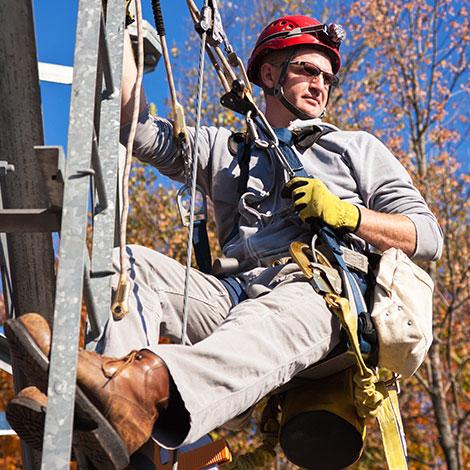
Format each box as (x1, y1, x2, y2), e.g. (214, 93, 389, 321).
(111, 0, 144, 320)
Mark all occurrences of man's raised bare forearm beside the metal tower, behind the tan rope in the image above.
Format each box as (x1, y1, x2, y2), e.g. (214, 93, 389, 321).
(121, 31, 147, 126)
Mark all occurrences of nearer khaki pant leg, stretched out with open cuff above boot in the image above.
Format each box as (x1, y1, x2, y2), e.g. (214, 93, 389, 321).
(151, 264, 339, 447)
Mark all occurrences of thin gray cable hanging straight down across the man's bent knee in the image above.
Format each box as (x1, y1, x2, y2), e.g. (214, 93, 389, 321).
(181, 0, 207, 344)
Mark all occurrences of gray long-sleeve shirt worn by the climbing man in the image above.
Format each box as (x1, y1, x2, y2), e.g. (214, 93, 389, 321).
(122, 108, 442, 268)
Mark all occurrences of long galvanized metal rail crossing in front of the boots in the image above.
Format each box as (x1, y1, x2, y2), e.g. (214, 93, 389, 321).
(41, 0, 124, 470)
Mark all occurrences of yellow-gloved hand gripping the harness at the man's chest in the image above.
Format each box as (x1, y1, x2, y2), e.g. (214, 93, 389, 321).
(282, 176, 361, 232)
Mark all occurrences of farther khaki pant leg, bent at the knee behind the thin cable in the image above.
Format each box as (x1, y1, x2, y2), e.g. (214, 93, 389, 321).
(97, 245, 231, 357)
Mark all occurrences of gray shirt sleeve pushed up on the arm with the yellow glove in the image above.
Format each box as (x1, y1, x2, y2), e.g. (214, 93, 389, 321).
(346, 132, 443, 260)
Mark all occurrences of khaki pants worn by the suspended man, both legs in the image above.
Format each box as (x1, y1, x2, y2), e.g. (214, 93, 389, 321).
(99, 245, 339, 447)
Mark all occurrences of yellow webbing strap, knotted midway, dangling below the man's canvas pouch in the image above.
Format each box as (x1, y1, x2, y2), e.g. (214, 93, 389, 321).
(325, 294, 408, 470)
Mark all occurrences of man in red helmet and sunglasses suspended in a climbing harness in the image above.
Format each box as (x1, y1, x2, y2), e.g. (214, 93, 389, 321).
(9, 16, 442, 466)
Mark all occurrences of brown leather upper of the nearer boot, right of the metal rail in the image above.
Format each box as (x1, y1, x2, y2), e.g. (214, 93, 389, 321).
(77, 349, 170, 454)
